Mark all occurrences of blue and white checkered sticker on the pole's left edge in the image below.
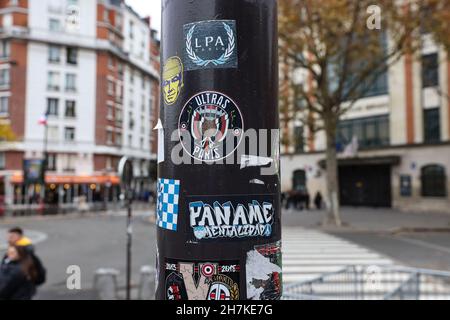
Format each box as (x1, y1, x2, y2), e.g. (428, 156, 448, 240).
(156, 179, 180, 231)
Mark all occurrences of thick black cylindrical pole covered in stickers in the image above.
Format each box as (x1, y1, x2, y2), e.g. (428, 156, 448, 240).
(156, 0, 282, 300)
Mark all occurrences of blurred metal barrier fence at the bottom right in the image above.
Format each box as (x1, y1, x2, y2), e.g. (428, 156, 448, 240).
(283, 266, 450, 300)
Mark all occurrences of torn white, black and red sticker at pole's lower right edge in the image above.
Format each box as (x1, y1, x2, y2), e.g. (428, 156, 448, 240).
(246, 241, 283, 300)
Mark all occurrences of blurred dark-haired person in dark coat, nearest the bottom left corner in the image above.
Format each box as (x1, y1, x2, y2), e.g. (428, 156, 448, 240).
(0, 246, 38, 300)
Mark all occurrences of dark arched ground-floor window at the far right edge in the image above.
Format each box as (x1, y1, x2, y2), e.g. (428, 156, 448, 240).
(421, 165, 447, 197)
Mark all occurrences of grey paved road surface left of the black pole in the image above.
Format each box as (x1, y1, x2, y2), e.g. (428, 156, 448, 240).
(0, 216, 156, 299)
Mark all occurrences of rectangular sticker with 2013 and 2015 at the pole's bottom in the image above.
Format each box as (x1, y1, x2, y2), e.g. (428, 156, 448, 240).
(165, 259, 241, 300)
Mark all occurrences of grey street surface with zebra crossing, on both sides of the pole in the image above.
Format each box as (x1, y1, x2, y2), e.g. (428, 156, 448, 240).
(0, 208, 450, 299)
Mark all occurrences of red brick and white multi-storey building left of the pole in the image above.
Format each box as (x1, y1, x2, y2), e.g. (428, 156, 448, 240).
(0, 0, 159, 212)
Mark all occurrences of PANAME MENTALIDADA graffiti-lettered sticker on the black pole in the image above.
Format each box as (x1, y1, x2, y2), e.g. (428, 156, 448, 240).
(186, 195, 276, 241)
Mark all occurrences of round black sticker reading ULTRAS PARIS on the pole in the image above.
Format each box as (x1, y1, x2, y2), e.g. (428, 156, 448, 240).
(178, 91, 244, 162)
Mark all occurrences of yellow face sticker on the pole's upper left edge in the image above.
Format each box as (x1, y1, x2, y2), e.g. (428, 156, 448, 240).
(162, 56, 184, 106)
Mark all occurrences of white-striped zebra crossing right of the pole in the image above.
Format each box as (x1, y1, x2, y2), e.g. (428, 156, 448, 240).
(282, 227, 394, 284)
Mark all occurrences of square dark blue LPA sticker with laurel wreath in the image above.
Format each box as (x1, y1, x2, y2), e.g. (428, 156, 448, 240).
(183, 20, 238, 71)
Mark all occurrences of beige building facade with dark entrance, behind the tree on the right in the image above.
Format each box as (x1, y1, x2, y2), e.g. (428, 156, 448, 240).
(281, 35, 450, 213)
